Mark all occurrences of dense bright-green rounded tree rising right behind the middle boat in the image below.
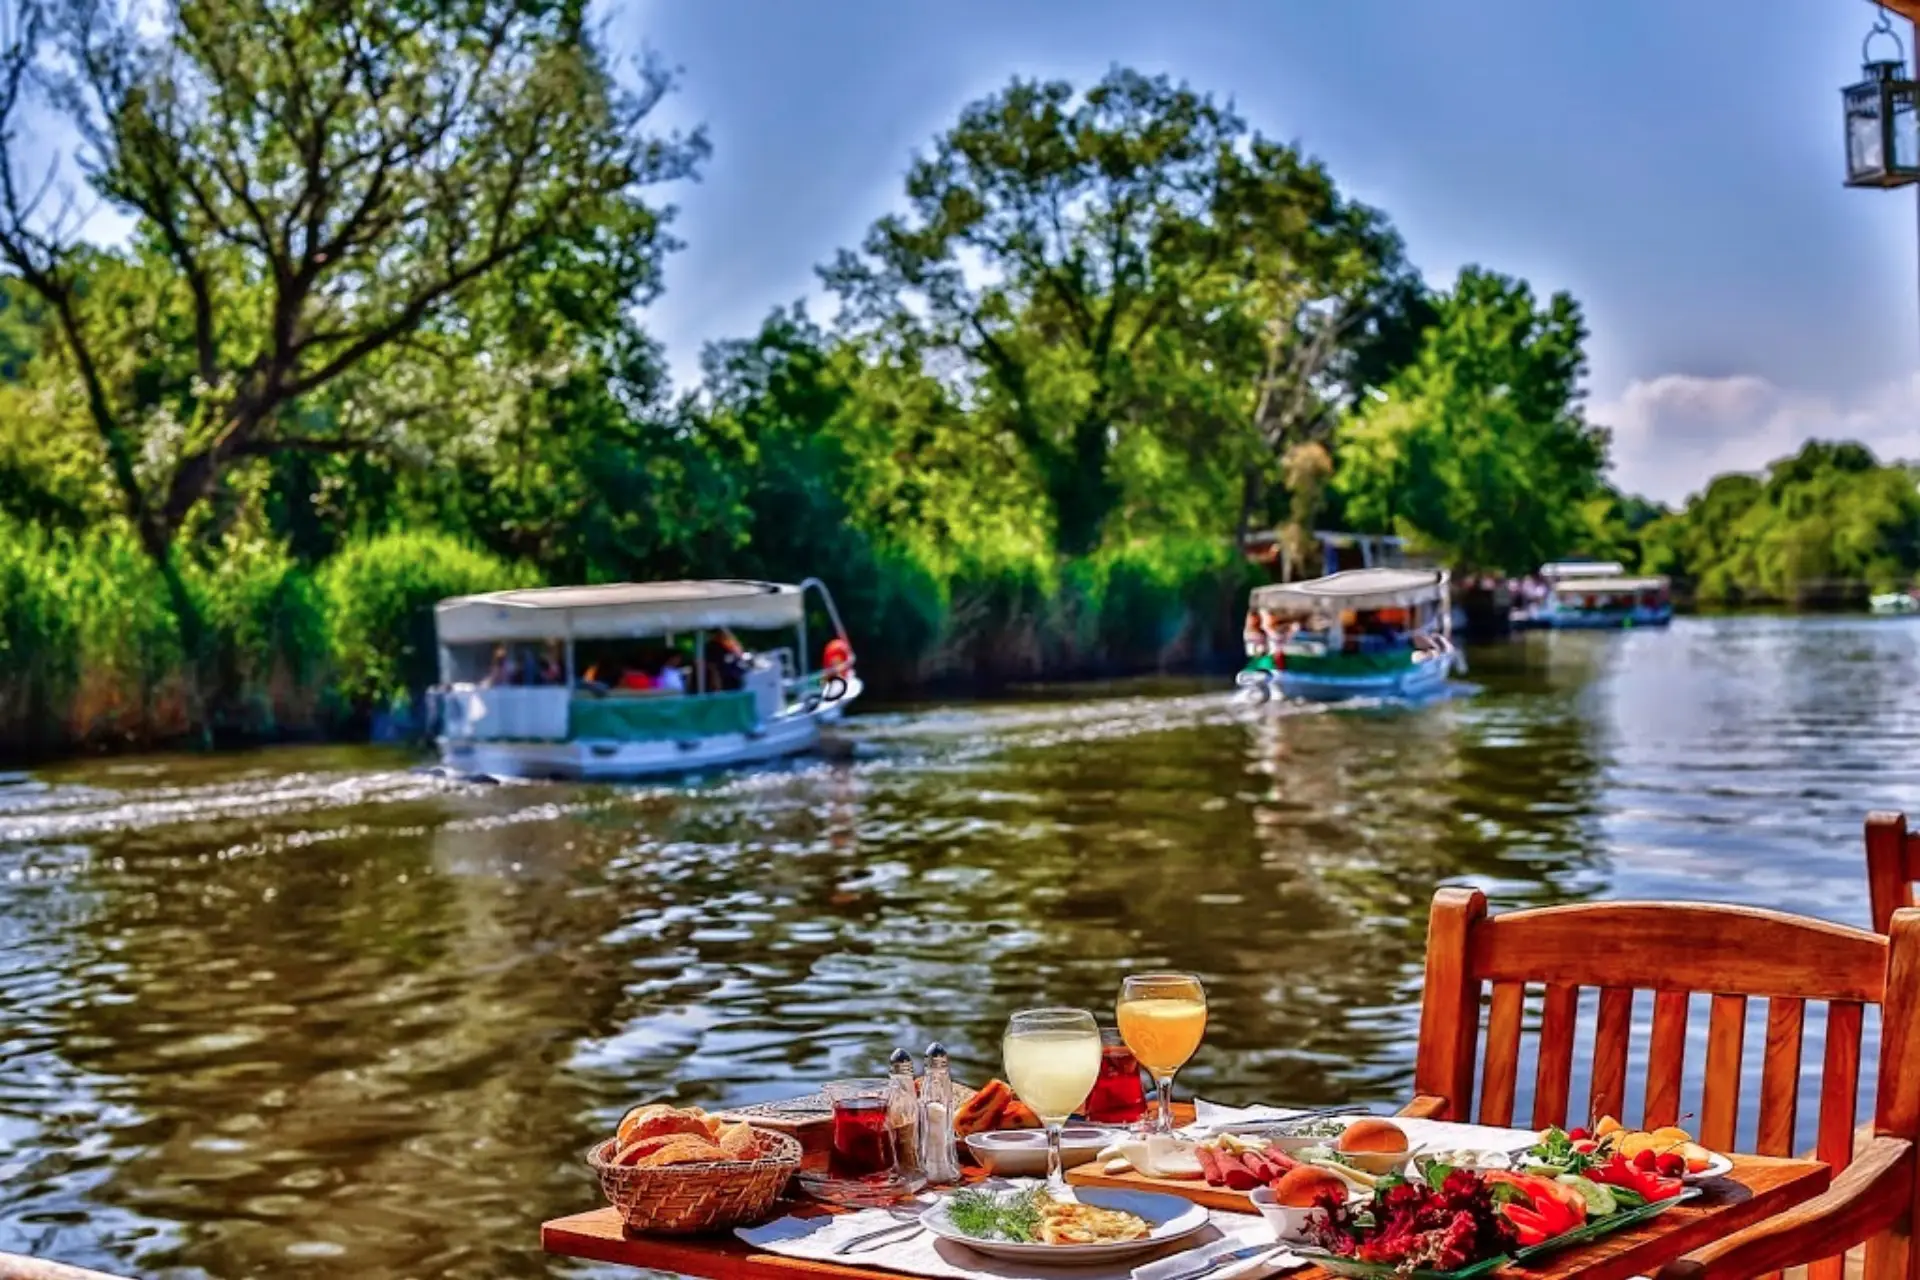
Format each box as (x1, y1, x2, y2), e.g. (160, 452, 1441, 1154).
(1334, 267, 1607, 572)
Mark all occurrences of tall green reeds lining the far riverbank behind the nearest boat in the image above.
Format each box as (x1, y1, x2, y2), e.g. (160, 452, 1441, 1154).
(0, 524, 1252, 760)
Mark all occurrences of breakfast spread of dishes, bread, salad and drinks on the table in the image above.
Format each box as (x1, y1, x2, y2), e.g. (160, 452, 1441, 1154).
(589, 975, 1732, 1280)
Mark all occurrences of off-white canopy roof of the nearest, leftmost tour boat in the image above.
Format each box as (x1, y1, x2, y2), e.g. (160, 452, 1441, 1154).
(434, 578, 801, 645)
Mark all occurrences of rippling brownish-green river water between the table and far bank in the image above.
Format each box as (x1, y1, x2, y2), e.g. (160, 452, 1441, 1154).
(0, 618, 1920, 1278)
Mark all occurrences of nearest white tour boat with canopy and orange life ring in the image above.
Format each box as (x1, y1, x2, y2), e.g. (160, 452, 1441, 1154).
(434, 578, 862, 779)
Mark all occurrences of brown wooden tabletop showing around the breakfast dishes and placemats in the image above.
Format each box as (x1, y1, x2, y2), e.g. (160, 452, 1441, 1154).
(540, 1155, 1832, 1280)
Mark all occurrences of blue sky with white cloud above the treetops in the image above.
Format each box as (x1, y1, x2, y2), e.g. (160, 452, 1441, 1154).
(611, 0, 1920, 501)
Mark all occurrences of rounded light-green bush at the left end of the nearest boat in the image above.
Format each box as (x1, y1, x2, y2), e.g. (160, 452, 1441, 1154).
(319, 533, 538, 706)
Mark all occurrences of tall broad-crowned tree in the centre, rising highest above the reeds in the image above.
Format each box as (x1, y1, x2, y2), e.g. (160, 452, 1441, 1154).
(824, 69, 1419, 555)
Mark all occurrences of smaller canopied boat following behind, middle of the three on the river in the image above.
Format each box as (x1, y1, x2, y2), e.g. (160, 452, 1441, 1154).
(1236, 568, 1459, 702)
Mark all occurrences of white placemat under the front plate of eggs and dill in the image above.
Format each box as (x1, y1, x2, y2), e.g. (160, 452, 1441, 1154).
(735, 1209, 1304, 1280)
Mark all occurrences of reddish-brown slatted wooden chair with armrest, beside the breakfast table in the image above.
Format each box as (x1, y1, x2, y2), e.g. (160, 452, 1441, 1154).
(1405, 889, 1920, 1280)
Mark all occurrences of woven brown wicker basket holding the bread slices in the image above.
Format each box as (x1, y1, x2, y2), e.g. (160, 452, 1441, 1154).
(588, 1128, 801, 1236)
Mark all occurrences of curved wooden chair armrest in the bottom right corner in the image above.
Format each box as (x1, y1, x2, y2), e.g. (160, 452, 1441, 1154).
(1655, 1138, 1914, 1280)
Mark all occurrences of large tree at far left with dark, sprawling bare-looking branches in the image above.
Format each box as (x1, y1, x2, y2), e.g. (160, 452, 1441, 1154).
(0, 0, 705, 652)
